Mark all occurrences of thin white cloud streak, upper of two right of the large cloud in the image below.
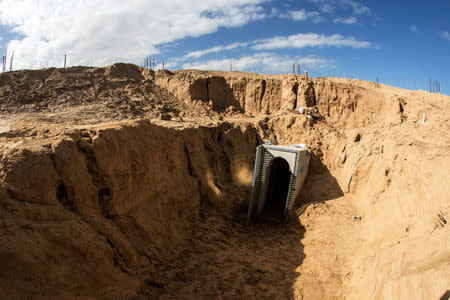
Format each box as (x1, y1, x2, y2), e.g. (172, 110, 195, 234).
(252, 33, 373, 50)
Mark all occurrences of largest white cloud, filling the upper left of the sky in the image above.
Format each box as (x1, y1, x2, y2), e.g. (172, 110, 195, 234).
(0, 0, 267, 68)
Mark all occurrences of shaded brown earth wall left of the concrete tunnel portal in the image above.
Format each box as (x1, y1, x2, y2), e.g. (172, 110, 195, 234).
(0, 121, 258, 297)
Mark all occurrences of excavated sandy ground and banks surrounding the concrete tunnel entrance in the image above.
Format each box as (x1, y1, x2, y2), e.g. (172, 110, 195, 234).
(0, 64, 450, 299)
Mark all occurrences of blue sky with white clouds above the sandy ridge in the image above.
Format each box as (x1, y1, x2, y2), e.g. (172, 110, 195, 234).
(0, 0, 450, 95)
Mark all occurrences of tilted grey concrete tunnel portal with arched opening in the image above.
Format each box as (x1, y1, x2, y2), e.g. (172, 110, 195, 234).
(247, 143, 311, 224)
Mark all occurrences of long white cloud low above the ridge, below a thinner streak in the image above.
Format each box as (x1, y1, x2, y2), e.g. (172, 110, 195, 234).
(182, 52, 332, 73)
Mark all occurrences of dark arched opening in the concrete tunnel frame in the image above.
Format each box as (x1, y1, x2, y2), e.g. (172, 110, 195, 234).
(262, 157, 291, 219)
